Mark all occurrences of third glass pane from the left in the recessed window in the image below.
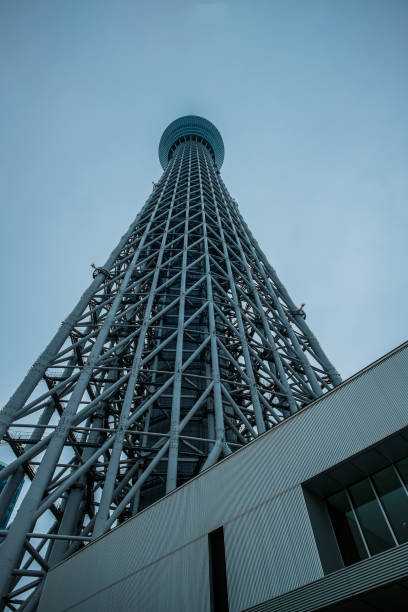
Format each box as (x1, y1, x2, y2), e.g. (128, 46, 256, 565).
(372, 466, 408, 544)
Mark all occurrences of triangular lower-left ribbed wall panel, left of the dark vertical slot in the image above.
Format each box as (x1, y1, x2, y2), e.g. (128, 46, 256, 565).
(40, 537, 210, 612)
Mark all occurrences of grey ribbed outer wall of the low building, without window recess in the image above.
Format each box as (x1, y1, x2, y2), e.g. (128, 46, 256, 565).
(39, 345, 408, 612)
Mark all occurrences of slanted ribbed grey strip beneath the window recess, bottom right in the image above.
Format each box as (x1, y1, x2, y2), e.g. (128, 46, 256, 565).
(247, 544, 408, 612)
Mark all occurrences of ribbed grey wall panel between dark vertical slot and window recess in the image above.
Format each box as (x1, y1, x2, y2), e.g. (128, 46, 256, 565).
(225, 486, 322, 611)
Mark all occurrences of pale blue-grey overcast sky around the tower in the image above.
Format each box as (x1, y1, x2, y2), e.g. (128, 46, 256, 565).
(0, 0, 408, 403)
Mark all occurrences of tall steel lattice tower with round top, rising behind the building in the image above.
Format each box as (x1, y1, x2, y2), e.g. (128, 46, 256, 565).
(0, 116, 340, 610)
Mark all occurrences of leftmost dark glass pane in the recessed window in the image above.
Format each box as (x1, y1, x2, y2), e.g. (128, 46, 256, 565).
(327, 491, 368, 565)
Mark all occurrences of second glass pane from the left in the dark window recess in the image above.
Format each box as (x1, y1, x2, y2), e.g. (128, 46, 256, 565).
(349, 479, 395, 555)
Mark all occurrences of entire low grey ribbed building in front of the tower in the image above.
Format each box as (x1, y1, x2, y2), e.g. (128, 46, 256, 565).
(39, 343, 408, 612)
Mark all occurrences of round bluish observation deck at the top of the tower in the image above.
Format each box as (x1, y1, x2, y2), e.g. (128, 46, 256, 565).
(159, 115, 224, 170)
